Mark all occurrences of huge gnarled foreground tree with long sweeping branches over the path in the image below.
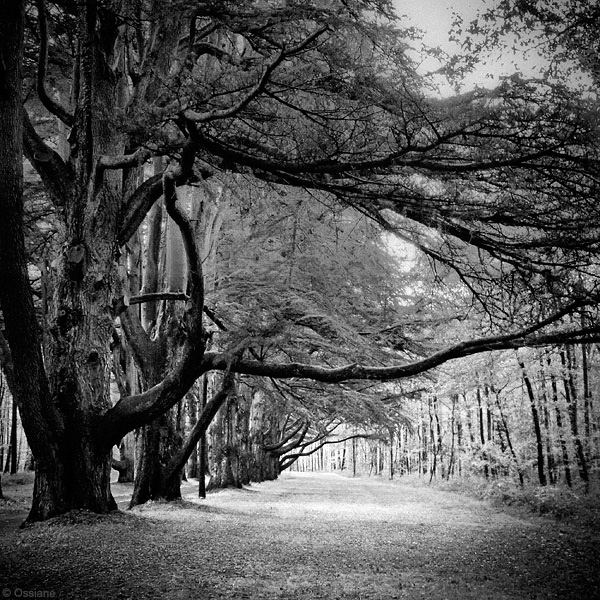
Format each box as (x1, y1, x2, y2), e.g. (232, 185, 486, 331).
(0, 0, 600, 520)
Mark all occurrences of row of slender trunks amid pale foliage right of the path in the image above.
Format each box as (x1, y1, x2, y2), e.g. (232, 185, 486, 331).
(288, 347, 600, 489)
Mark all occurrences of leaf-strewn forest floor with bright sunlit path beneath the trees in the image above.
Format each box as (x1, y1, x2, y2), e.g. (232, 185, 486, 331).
(0, 474, 600, 600)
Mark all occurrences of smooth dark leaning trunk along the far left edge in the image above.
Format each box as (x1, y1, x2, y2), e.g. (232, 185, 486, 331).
(0, 1, 68, 519)
